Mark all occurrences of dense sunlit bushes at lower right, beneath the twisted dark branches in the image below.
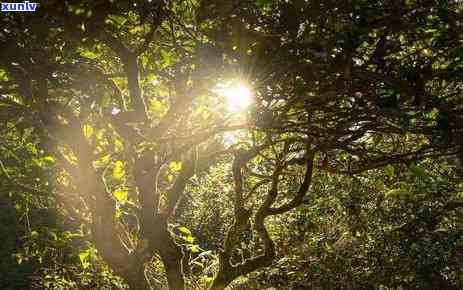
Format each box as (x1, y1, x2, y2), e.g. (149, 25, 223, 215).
(256, 161, 463, 289)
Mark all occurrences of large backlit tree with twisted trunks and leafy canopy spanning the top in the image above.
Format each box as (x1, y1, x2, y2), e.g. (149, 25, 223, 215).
(0, 0, 462, 290)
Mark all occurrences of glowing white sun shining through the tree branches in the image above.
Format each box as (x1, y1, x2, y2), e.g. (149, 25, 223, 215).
(215, 83, 252, 111)
